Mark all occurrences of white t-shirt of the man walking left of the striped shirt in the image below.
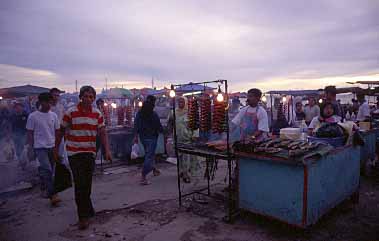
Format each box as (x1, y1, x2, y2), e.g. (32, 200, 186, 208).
(26, 111, 59, 148)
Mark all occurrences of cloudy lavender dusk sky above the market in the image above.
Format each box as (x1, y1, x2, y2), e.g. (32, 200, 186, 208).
(0, 0, 379, 91)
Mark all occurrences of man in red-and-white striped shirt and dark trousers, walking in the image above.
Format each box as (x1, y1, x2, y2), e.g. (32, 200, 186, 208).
(54, 86, 112, 229)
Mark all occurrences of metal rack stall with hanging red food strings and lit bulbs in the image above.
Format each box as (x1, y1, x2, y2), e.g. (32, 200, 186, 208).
(169, 80, 238, 221)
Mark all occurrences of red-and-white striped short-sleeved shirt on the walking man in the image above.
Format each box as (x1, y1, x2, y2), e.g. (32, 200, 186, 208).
(62, 104, 105, 156)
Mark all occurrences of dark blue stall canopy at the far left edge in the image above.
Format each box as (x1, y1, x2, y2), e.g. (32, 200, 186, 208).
(0, 85, 50, 98)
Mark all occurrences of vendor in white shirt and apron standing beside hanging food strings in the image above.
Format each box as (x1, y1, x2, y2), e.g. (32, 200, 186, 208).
(232, 89, 269, 140)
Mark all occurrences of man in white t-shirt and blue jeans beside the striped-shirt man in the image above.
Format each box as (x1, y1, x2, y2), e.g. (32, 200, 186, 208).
(26, 92, 61, 206)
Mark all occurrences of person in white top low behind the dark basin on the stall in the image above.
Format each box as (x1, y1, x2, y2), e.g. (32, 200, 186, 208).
(308, 101, 341, 135)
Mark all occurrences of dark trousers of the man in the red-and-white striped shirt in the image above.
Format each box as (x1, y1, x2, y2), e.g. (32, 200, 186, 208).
(68, 153, 95, 220)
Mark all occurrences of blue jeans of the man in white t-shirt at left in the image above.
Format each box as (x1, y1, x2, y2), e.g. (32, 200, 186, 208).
(34, 148, 55, 198)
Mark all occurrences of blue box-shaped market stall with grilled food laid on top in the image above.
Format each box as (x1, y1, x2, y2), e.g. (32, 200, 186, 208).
(235, 139, 360, 228)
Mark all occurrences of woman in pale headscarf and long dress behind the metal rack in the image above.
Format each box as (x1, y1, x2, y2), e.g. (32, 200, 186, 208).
(175, 97, 199, 183)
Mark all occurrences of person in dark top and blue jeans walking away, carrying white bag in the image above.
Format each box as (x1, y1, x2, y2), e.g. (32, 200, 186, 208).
(134, 95, 163, 185)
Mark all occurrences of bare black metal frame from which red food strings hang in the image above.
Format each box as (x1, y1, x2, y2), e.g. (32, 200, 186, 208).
(171, 80, 238, 222)
